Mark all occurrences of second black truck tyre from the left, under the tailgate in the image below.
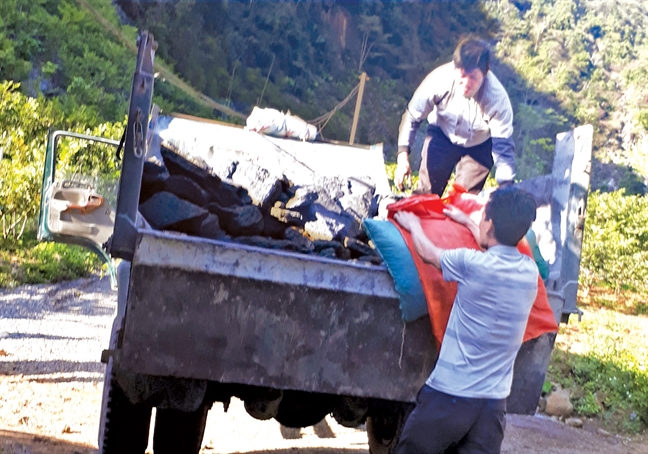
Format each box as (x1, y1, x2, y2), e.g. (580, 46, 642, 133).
(153, 404, 209, 454)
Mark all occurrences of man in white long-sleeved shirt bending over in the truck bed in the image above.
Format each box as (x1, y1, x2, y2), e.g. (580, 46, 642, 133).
(394, 38, 515, 196)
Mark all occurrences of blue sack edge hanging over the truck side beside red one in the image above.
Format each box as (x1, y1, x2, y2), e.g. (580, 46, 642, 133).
(362, 219, 428, 322)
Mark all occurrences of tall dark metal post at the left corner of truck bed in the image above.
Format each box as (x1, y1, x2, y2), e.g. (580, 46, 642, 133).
(108, 31, 157, 260)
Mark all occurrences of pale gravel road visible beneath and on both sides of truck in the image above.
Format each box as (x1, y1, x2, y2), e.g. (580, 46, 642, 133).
(0, 277, 648, 454)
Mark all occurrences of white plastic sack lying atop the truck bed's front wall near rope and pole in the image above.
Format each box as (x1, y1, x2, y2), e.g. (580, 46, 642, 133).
(246, 107, 317, 142)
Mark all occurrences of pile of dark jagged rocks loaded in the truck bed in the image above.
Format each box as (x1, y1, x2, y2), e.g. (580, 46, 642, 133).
(139, 147, 382, 264)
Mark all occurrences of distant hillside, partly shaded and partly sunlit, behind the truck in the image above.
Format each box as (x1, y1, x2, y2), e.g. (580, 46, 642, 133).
(117, 0, 648, 193)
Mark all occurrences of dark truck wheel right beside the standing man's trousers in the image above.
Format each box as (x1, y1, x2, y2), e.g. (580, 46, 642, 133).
(366, 405, 414, 454)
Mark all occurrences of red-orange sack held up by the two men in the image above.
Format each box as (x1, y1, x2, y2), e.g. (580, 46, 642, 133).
(387, 185, 558, 348)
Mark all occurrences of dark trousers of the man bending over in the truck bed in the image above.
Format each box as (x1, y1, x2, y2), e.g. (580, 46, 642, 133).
(414, 125, 493, 197)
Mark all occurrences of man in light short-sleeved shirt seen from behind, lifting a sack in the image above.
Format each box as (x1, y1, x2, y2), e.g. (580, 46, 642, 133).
(394, 187, 538, 454)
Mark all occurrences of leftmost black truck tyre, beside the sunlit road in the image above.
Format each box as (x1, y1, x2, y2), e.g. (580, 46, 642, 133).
(99, 358, 151, 454)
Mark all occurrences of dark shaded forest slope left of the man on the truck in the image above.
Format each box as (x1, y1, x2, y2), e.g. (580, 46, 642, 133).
(118, 0, 495, 144)
